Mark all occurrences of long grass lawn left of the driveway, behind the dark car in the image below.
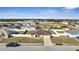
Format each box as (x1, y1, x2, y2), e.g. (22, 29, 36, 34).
(0, 37, 43, 43)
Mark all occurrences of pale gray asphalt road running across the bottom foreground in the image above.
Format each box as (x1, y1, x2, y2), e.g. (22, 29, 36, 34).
(0, 46, 79, 51)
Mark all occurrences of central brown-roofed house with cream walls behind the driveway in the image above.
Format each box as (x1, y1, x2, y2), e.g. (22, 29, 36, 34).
(27, 29, 51, 38)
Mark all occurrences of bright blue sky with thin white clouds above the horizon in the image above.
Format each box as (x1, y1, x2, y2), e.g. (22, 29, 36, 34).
(0, 7, 79, 19)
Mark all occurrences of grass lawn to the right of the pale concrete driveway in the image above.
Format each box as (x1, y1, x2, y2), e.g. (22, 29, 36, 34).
(51, 37, 79, 43)
